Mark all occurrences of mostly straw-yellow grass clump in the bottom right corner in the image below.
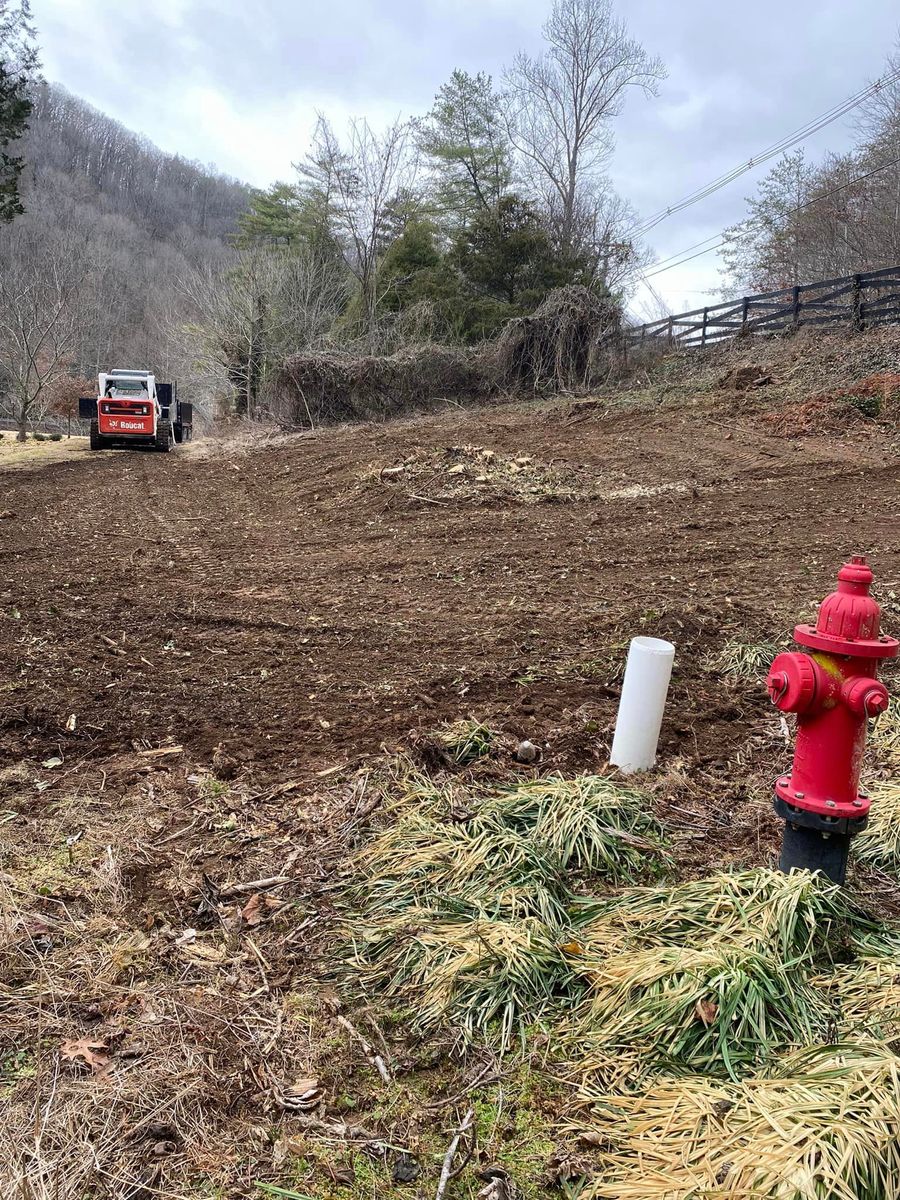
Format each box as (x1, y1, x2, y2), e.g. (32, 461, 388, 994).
(580, 1045, 900, 1200)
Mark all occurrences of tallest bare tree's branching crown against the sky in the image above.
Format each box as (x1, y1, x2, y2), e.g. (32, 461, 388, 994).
(506, 0, 666, 250)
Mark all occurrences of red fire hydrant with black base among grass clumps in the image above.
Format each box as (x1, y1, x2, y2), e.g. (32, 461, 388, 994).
(766, 556, 900, 883)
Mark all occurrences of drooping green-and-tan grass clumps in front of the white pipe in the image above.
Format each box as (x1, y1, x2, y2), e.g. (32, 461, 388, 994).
(354, 773, 662, 1048)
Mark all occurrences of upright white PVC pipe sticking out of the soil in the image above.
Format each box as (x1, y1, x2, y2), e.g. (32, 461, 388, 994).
(610, 637, 674, 774)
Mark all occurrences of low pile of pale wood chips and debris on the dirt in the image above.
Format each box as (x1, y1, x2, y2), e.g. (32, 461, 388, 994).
(361, 445, 595, 504)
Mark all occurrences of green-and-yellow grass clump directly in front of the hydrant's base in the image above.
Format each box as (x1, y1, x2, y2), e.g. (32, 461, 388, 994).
(569, 870, 894, 1084)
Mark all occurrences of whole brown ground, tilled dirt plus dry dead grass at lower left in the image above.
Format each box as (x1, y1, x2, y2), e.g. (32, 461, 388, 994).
(0, 340, 900, 1200)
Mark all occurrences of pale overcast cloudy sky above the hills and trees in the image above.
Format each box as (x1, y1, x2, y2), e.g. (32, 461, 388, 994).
(32, 0, 900, 312)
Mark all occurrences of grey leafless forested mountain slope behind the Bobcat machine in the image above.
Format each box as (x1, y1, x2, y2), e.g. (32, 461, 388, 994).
(0, 83, 248, 398)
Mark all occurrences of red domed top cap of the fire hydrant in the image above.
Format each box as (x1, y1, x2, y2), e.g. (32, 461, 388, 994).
(794, 554, 900, 659)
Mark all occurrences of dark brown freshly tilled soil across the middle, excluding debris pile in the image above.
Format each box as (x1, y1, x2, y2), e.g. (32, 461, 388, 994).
(0, 393, 900, 776)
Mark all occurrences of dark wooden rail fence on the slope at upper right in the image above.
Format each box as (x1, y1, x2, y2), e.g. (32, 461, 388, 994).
(626, 266, 900, 347)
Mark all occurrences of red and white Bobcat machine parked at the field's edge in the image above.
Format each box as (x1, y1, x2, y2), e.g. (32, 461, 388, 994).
(78, 371, 193, 451)
